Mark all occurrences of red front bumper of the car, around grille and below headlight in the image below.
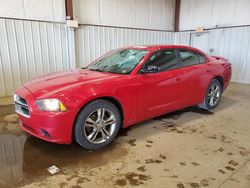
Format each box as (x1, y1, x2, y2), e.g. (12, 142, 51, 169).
(16, 87, 77, 144)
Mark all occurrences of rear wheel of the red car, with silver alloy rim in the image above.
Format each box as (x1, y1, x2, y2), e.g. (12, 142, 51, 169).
(198, 79, 222, 110)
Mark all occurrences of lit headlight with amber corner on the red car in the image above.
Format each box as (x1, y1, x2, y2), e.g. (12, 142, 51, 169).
(36, 99, 67, 112)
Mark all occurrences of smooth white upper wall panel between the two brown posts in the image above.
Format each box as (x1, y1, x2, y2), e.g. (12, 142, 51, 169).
(73, 0, 175, 30)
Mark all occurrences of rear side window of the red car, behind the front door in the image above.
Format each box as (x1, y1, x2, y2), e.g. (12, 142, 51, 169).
(179, 50, 200, 66)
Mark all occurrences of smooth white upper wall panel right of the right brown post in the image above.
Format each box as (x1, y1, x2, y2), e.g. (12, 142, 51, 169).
(180, 0, 250, 30)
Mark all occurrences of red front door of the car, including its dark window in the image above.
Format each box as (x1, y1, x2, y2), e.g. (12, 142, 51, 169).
(137, 49, 189, 120)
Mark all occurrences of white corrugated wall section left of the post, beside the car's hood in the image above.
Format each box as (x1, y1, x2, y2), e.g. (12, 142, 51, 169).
(0, 19, 74, 96)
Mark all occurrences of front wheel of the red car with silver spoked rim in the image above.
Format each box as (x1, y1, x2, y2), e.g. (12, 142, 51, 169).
(74, 99, 121, 151)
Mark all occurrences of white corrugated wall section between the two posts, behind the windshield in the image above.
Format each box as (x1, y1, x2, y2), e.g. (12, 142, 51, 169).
(75, 26, 174, 67)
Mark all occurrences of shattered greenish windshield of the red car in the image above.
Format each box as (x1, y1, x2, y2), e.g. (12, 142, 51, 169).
(87, 49, 148, 74)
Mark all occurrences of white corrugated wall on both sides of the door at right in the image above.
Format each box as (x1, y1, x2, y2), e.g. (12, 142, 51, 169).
(174, 26, 250, 83)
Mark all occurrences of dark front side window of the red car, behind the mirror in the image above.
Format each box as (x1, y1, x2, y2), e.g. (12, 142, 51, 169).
(145, 49, 178, 72)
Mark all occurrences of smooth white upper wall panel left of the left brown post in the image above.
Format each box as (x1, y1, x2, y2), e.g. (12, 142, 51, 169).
(0, 0, 66, 22)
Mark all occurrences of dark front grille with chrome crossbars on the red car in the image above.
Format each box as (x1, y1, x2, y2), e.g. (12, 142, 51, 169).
(14, 95, 30, 118)
